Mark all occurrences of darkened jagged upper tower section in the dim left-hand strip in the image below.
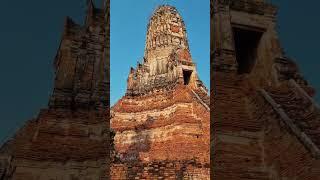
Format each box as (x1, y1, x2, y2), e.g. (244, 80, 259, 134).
(49, 1, 108, 109)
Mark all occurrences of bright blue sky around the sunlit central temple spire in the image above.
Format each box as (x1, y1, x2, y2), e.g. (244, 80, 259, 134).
(110, 0, 210, 105)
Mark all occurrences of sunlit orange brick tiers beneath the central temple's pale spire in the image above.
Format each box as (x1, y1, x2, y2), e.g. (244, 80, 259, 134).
(111, 85, 210, 165)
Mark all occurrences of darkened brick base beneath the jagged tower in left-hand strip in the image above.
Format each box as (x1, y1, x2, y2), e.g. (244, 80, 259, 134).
(0, 110, 109, 180)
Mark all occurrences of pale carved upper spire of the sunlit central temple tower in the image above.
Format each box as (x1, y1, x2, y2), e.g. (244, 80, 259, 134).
(127, 5, 206, 95)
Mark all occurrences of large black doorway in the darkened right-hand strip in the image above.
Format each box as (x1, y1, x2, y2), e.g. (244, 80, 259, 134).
(233, 28, 262, 74)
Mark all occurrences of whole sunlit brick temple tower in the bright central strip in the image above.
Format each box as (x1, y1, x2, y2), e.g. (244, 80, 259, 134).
(110, 5, 210, 179)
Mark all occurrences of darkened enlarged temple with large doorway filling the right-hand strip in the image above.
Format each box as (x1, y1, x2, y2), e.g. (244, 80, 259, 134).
(214, 0, 320, 180)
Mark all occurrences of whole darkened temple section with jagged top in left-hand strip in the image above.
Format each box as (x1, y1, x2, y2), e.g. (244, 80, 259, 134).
(0, 1, 109, 180)
